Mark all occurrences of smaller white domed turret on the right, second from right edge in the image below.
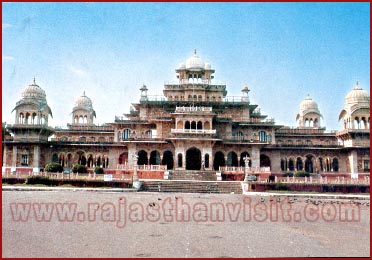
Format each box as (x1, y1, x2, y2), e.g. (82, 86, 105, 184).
(296, 95, 322, 127)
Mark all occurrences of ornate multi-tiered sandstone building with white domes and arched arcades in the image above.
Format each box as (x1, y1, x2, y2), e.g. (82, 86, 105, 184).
(3, 52, 370, 178)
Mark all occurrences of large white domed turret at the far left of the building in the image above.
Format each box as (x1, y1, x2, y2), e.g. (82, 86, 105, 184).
(13, 79, 53, 125)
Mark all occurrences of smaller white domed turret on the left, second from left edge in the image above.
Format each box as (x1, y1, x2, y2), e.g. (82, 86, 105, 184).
(72, 91, 96, 125)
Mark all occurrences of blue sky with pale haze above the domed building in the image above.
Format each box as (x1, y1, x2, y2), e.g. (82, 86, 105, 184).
(2, 2, 370, 130)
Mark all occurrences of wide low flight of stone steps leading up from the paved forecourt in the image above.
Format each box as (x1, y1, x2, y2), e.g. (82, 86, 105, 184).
(141, 180, 242, 194)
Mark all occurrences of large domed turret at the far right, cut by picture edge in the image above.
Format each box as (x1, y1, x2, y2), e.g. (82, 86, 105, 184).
(339, 81, 370, 129)
